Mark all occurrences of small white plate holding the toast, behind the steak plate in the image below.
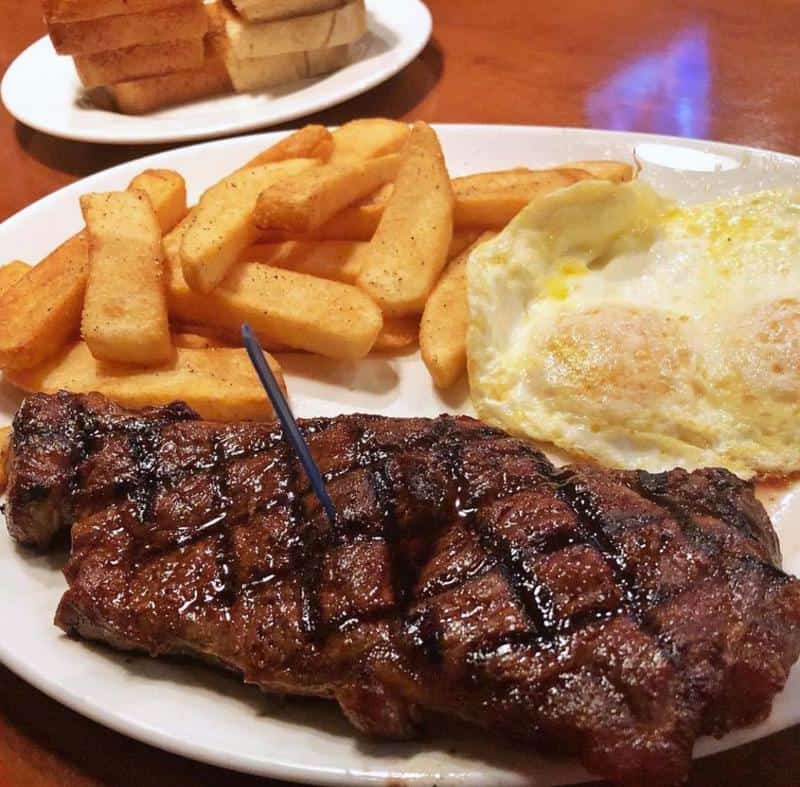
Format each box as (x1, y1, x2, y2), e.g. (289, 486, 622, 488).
(0, 0, 431, 145)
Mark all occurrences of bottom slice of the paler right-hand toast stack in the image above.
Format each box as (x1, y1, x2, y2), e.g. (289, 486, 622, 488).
(225, 44, 350, 93)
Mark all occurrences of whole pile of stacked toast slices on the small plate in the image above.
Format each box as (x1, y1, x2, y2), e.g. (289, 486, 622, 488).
(43, 0, 367, 114)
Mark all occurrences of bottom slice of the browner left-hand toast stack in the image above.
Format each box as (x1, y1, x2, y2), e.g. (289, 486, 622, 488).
(108, 37, 233, 115)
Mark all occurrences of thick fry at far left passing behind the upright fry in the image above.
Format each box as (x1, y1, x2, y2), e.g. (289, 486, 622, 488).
(0, 168, 191, 369)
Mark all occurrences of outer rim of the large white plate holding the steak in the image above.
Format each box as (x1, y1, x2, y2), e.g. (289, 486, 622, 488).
(0, 123, 800, 785)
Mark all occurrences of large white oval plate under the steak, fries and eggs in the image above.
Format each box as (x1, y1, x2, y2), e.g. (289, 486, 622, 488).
(0, 126, 800, 787)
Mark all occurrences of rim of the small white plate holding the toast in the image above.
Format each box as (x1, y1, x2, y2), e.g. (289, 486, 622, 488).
(0, 0, 433, 145)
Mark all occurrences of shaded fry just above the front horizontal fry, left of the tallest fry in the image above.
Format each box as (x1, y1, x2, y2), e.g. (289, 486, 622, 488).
(240, 240, 369, 284)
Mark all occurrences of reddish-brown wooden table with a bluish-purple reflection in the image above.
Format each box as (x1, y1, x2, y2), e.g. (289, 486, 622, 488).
(0, 0, 800, 787)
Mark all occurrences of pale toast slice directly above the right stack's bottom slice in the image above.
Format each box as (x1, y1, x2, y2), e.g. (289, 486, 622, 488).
(222, 0, 367, 60)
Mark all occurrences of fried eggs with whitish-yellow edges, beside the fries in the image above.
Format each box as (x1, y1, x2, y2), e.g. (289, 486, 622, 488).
(467, 181, 800, 477)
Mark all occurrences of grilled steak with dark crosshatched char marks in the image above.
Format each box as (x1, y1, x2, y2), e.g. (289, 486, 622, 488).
(8, 393, 800, 785)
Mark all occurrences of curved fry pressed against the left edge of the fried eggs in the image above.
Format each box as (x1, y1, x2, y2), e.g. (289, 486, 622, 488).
(419, 232, 494, 388)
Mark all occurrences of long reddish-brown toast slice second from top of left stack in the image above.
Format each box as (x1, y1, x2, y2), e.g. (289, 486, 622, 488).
(49, 0, 208, 55)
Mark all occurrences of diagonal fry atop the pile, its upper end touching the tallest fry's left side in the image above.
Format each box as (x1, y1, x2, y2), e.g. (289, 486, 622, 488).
(255, 153, 400, 235)
